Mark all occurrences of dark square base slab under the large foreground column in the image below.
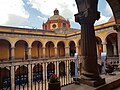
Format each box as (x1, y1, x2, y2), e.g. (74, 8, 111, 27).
(80, 78, 105, 87)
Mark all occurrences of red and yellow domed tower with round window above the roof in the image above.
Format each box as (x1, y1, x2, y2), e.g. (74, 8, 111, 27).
(42, 9, 70, 30)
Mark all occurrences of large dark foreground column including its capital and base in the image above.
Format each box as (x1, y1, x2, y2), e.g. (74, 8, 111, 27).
(75, 0, 105, 87)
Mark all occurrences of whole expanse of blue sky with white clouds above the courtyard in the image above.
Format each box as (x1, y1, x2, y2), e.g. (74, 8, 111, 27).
(0, 0, 113, 29)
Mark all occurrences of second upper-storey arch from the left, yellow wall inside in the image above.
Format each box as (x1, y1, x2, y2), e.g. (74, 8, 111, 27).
(15, 40, 28, 60)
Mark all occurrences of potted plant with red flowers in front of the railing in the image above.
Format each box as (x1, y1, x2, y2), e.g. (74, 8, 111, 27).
(48, 74, 61, 90)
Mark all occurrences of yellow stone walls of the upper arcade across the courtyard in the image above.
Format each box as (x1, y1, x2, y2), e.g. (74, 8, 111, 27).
(0, 22, 117, 59)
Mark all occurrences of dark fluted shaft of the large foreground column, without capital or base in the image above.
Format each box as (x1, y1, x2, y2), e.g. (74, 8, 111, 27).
(81, 23, 99, 78)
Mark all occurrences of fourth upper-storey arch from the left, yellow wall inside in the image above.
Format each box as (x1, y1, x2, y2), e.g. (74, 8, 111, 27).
(45, 41, 55, 58)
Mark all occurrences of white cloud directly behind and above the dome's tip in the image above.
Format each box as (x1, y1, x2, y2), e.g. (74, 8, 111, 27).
(29, 0, 77, 19)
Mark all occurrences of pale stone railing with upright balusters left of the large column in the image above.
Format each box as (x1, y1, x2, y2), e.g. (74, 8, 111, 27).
(0, 58, 80, 90)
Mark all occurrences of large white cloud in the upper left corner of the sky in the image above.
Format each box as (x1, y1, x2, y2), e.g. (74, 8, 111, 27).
(0, 0, 29, 25)
